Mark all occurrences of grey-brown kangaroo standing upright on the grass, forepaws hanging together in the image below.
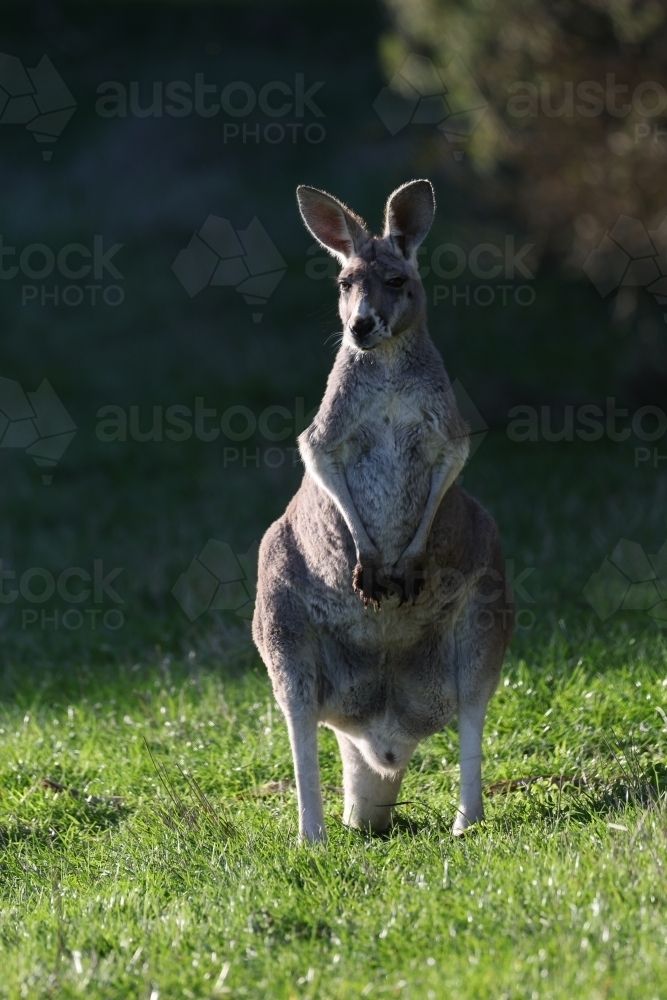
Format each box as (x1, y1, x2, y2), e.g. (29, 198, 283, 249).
(253, 180, 514, 840)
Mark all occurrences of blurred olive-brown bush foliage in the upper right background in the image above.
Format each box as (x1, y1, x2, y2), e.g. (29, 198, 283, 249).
(381, 0, 667, 264)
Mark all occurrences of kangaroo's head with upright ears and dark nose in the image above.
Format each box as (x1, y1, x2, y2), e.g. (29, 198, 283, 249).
(296, 181, 435, 351)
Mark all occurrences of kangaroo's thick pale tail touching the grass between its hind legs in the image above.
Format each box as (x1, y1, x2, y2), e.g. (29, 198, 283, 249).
(336, 730, 403, 833)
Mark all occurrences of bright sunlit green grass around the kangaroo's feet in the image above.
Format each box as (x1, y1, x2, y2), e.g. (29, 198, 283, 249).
(0, 634, 667, 998)
